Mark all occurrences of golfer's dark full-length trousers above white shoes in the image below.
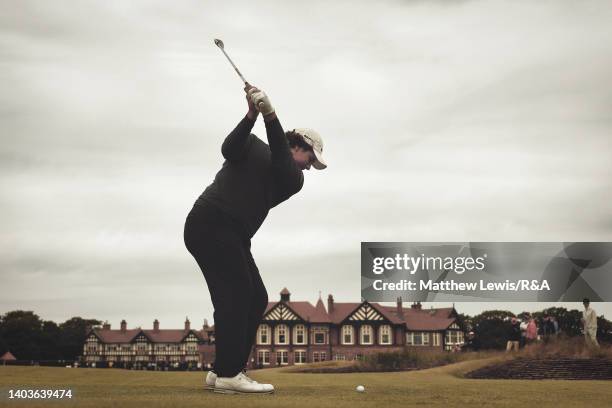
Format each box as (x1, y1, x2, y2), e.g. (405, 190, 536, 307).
(184, 203, 268, 377)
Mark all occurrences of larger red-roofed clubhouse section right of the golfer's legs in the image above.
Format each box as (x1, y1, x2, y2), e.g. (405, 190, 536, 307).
(248, 288, 464, 368)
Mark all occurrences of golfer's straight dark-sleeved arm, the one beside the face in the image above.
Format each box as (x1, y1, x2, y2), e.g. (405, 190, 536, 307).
(264, 114, 304, 192)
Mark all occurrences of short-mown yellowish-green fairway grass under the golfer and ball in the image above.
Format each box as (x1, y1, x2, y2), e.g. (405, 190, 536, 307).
(0, 358, 612, 408)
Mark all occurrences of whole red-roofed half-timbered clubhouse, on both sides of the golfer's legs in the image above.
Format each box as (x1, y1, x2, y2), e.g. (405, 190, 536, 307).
(83, 288, 463, 368)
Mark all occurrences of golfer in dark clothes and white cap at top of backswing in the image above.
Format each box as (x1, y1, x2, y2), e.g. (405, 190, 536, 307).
(184, 83, 327, 394)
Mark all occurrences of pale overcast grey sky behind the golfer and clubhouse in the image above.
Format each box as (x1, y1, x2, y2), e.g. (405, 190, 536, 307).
(0, 0, 612, 328)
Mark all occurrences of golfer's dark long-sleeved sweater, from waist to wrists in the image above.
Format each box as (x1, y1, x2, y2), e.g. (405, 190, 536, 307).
(195, 116, 304, 238)
